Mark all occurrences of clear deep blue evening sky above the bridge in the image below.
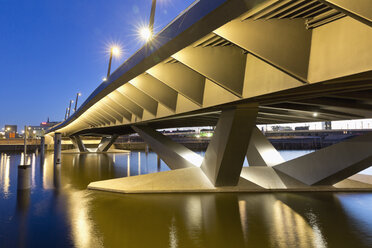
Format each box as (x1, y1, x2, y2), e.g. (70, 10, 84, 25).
(0, 0, 194, 130)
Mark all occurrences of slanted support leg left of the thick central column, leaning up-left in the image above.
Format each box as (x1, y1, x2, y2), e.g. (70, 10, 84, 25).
(132, 126, 203, 170)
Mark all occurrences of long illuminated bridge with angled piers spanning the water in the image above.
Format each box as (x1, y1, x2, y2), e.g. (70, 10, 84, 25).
(49, 0, 372, 193)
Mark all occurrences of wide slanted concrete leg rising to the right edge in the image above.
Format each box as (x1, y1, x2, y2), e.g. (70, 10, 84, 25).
(273, 132, 372, 185)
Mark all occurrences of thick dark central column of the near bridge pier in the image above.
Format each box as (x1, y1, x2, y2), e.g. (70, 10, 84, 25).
(201, 104, 258, 186)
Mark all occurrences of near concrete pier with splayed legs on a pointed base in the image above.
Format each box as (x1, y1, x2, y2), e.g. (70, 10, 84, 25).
(88, 106, 372, 193)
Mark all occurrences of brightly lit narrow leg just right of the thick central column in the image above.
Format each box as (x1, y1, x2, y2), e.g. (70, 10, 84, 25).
(247, 127, 285, 166)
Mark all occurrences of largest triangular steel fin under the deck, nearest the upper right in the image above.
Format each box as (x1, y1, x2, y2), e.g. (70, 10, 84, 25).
(214, 19, 312, 83)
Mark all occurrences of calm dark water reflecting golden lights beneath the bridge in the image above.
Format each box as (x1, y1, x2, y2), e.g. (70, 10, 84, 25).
(0, 152, 372, 248)
